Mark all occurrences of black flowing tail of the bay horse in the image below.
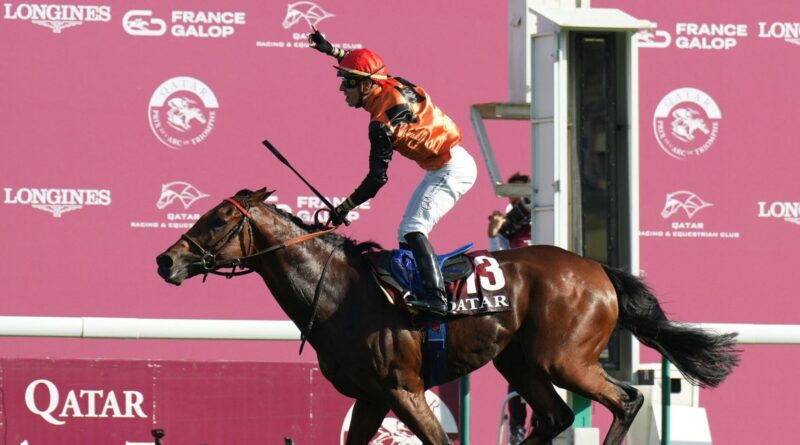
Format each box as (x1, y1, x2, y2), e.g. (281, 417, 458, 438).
(603, 266, 740, 387)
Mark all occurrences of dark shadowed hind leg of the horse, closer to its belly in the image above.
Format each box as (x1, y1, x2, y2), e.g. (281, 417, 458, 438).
(494, 344, 575, 445)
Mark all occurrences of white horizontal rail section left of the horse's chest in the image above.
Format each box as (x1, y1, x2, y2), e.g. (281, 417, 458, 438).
(0, 316, 300, 340)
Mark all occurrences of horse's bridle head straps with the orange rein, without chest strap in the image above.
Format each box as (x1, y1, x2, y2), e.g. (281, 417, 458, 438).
(181, 198, 336, 282)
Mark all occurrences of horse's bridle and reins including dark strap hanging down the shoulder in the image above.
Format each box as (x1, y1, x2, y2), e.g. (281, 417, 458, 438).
(181, 198, 338, 354)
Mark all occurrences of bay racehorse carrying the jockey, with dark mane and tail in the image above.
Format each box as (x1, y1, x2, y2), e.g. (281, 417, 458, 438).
(156, 189, 738, 445)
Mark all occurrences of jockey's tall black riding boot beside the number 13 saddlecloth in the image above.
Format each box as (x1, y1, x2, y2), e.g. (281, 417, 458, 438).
(405, 232, 447, 316)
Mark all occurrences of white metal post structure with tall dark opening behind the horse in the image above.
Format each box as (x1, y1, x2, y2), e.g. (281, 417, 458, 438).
(472, 0, 655, 440)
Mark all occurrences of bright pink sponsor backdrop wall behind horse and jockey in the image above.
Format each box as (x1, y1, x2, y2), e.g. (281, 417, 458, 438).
(0, 0, 800, 445)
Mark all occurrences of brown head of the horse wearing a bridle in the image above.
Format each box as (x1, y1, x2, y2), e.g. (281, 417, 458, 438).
(156, 189, 272, 285)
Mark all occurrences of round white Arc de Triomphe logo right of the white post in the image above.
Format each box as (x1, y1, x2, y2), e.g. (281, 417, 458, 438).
(653, 88, 722, 160)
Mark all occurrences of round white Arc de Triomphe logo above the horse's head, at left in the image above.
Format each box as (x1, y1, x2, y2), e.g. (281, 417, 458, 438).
(148, 76, 219, 150)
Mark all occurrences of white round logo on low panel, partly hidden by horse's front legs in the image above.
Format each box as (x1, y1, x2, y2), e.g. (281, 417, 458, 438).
(339, 391, 458, 445)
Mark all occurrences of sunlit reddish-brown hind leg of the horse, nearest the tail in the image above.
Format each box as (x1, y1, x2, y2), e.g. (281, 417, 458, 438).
(559, 363, 644, 445)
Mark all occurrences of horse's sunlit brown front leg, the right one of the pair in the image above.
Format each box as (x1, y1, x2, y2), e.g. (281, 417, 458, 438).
(389, 387, 452, 445)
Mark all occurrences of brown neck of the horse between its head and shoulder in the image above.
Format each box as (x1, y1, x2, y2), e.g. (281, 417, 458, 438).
(254, 210, 350, 324)
